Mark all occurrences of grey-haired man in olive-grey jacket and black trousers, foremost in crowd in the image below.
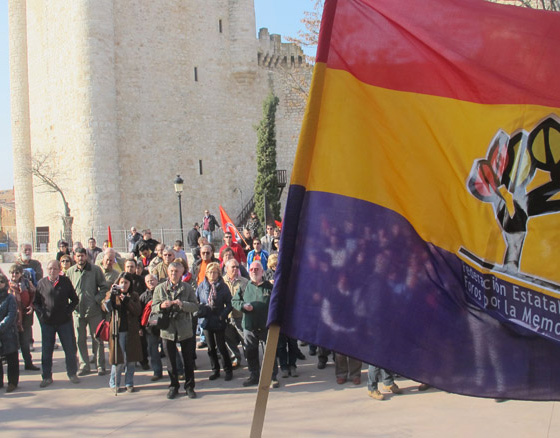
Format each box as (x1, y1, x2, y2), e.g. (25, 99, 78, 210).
(152, 262, 198, 399)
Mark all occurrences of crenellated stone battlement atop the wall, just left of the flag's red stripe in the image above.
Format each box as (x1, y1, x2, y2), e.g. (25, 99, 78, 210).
(257, 27, 310, 68)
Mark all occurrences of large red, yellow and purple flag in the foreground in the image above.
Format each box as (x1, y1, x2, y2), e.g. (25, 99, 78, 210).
(269, 0, 560, 400)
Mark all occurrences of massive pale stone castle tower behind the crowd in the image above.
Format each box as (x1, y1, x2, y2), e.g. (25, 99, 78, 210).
(10, 0, 311, 249)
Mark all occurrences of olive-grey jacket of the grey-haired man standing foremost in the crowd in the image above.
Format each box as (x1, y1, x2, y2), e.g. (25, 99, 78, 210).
(152, 280, 198, 341)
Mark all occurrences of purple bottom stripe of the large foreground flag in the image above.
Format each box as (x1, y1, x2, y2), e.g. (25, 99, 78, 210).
(269, 186, 560, 400)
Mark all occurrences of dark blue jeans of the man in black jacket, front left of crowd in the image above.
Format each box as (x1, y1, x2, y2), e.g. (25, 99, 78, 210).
(41, 320, 78, 379)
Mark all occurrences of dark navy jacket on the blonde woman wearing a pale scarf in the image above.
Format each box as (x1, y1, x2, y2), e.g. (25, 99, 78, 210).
(196, 278, 233, 331)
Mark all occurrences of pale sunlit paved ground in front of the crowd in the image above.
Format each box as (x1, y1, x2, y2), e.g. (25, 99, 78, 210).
(0, 265, 560, 438)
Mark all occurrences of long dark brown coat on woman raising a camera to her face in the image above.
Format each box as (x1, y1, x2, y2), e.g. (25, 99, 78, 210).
(105, 291, 143, 365)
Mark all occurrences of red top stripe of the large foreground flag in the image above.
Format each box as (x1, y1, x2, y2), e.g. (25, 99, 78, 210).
(317, 0, 560, 107)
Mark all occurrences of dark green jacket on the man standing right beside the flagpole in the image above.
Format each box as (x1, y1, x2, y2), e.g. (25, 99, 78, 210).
(232, 281, 272, 331)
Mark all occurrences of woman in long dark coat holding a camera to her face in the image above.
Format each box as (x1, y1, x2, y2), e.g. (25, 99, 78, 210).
(104, 272, 142, 392)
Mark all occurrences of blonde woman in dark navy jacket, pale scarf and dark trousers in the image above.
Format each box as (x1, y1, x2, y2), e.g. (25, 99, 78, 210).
(196, 262, 233, 381)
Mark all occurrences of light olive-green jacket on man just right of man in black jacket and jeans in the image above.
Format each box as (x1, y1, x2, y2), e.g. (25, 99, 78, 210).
(66, 262, 109, 318)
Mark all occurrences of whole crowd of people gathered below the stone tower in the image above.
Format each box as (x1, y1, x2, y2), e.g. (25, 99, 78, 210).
(0, 210, 427, 400)
